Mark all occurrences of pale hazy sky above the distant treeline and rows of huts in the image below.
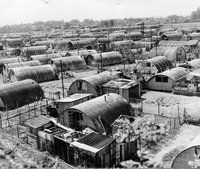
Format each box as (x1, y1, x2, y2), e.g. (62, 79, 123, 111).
(0, 0, 200, 26)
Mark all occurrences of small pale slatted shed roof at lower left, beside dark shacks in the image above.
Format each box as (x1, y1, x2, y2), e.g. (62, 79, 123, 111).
(25, 115, 53, 129)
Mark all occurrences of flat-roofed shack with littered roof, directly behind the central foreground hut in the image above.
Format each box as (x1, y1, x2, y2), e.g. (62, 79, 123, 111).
(102, 79, 141, 102)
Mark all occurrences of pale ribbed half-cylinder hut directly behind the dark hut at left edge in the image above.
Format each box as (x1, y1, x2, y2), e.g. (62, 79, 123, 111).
(9, 65, 58, 83)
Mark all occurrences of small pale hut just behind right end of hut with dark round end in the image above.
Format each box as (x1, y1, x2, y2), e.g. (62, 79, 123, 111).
(110, 40, 136, 51)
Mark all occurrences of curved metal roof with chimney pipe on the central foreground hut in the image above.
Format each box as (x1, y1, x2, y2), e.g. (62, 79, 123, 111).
(69, 93, 131, 134)
